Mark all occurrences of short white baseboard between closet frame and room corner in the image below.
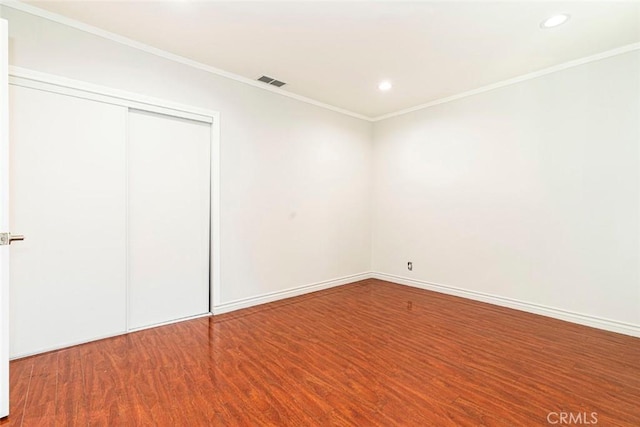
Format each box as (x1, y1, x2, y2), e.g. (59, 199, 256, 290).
(213, 272, 371, 315)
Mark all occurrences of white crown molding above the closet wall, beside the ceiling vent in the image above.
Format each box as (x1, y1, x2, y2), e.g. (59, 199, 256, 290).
(0, 0, 371, 122)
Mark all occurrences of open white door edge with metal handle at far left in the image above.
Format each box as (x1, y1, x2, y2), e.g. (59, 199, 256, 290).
(0, 19, 10, 417)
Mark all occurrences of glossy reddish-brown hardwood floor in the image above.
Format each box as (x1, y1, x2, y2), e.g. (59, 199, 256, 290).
(0, 280, 640, 426)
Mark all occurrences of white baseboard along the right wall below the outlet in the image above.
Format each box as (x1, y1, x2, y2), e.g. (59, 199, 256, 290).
(371, 272, 640, 337)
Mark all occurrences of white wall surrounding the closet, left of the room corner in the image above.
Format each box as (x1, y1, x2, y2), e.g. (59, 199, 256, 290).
(2, 6, 372, 304)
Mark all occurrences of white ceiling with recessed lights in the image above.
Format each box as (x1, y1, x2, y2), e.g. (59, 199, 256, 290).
(23, 0, 640, 117)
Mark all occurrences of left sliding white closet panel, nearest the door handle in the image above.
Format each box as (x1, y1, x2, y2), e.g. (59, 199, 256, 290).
(10, 86, 127, 357)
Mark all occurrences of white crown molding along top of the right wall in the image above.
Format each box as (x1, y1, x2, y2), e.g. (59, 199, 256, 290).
(371, 43, 640, 122)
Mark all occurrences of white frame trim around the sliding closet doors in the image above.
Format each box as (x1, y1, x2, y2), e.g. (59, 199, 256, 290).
(2, 66, 221, 332)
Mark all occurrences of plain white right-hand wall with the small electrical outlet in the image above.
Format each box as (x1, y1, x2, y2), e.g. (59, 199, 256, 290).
(373, 51, 640, 331)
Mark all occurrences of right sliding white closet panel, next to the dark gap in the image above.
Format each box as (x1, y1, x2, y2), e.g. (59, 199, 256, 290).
(128, 110, 211, 329)
